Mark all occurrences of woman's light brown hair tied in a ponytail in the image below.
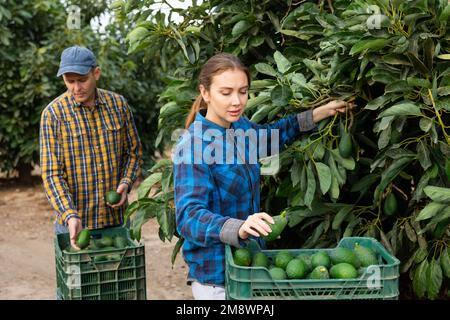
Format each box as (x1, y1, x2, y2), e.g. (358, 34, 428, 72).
(186, 53, 250, 129)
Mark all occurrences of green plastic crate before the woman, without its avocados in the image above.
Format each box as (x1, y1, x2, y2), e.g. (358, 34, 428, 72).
(225, 237, 400, 300)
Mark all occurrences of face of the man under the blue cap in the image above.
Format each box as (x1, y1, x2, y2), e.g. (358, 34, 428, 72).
(63, 67, 100, 104)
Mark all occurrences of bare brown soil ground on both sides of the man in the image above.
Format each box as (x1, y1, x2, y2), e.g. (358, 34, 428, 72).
(0, 177, 192, 300)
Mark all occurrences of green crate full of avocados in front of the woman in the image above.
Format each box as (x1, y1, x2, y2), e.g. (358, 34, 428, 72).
(225, 237, 400, 300)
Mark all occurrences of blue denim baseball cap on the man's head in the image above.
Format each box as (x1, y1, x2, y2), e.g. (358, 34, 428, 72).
(56, 46, 97, 77)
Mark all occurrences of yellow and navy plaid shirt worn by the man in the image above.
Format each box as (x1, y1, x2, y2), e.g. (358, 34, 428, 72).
(40, 89, 142, 229)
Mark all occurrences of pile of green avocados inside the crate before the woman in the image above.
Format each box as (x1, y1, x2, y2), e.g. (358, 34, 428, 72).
(233, 243, 379, 280)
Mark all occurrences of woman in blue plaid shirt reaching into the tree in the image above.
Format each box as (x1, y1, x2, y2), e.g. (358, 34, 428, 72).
(173, 53, 352, 299)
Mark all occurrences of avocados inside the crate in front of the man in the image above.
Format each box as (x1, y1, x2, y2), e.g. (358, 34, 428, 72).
(64, 229, 129, 262)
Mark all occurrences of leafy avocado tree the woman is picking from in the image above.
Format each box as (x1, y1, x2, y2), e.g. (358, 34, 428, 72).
(115, 0, 450, 299)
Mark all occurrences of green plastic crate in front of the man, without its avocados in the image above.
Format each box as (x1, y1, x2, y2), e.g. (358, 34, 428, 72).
(55, 227, 147, 300)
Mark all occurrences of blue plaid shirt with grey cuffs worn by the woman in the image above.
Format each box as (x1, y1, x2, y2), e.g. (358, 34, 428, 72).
(173, 110, 315, 286)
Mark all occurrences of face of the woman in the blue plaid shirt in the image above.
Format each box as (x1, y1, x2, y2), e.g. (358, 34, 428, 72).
(200, 69, 248, 128)
